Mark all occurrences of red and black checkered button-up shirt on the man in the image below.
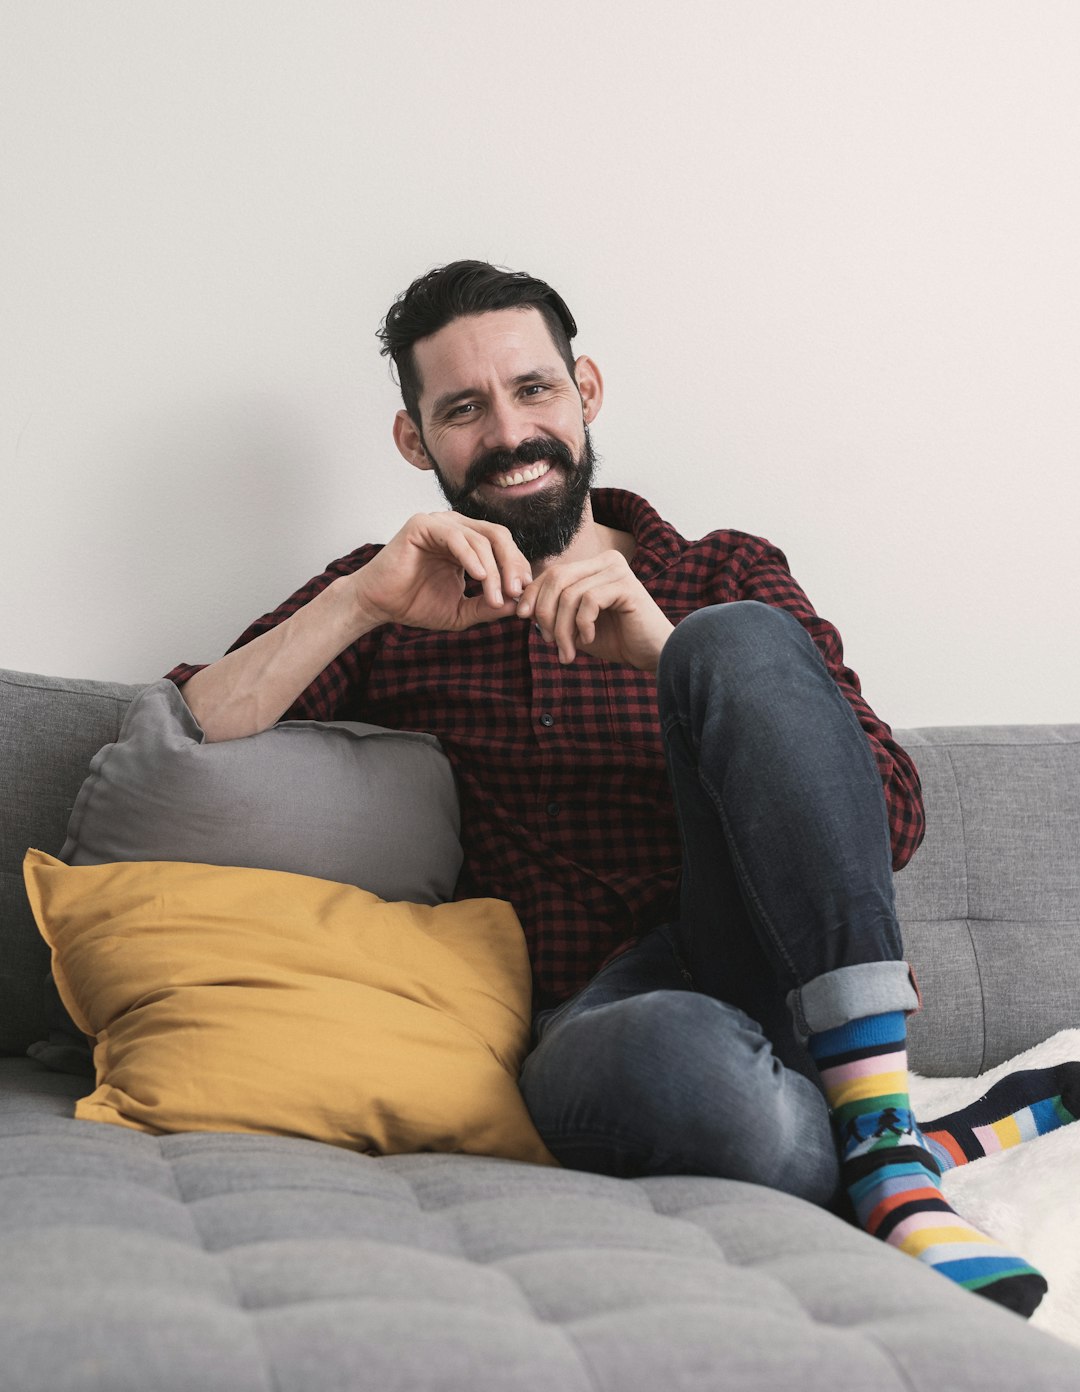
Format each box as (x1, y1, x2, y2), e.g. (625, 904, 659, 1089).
(168, 489, 923, 1005)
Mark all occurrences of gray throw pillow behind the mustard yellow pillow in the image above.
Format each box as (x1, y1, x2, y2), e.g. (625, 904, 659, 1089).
(28, 679, 462, 1076)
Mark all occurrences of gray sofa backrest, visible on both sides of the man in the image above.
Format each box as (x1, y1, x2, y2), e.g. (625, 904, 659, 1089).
(0, 671, 1080, 1075)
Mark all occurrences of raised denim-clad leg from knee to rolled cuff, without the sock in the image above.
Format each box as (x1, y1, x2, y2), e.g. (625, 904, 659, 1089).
(657, 601, 917, 1037)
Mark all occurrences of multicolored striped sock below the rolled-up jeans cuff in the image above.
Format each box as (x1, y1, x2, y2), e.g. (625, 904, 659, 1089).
(810, 1011, 1047, 1318)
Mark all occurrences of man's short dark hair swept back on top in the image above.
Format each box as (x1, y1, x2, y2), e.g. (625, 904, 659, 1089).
(379, 260, 578, 427)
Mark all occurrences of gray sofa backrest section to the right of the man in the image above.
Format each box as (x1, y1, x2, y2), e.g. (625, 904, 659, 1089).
(895, 725, 1080, 1076)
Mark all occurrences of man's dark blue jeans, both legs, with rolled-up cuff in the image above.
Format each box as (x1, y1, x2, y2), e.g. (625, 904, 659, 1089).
(521, 601, 917, 1204)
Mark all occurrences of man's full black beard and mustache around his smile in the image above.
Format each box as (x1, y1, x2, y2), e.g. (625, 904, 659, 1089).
(427, 426, 596, 565)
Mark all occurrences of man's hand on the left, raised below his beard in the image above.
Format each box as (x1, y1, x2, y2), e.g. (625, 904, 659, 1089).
(349, 512, 533, 632)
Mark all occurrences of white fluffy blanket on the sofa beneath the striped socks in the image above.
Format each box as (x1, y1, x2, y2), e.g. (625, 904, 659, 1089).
(912, 1030, 1080, 1346)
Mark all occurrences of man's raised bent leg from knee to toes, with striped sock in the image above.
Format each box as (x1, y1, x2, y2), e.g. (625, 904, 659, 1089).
(658, 604, 1047, 1315)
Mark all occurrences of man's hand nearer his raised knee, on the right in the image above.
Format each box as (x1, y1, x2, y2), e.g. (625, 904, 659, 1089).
(516, 551, 674, 672)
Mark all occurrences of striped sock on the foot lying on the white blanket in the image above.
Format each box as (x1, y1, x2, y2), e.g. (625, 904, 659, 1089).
(919, 1062, 1080, 1169)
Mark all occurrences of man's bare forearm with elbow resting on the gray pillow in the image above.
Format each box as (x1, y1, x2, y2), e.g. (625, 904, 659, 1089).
(181, 576, 377, 741)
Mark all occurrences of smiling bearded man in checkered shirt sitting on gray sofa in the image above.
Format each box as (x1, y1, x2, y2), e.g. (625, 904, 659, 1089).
(170, 262, 1074, 1315)
